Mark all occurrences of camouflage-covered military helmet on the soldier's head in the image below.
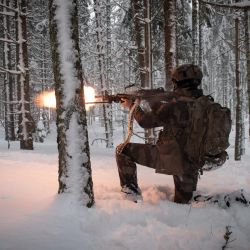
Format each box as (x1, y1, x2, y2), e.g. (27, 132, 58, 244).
(172, 64, 203, 86)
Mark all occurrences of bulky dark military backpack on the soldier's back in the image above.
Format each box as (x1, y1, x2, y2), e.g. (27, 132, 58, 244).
(184, 96, 232, 170)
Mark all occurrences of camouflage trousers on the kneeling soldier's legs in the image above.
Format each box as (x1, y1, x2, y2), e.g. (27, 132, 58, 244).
(116, 143, 198, 203)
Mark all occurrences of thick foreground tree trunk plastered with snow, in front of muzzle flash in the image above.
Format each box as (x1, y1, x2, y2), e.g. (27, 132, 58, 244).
(49, 0, 94, 207)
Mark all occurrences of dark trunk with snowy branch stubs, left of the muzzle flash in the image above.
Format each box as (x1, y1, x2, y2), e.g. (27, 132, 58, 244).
(16, 0, 34, 150)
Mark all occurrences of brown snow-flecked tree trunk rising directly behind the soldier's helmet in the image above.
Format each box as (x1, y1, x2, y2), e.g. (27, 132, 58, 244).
(164, 0, 176, 90)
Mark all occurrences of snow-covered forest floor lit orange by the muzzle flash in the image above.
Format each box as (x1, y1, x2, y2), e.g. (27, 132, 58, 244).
(0, 124, 250, 250)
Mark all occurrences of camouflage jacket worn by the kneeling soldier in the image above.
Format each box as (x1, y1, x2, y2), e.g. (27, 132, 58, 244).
(134, 89, 202, 175)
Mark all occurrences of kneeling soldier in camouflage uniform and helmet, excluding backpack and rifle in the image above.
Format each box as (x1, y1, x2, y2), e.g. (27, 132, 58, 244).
(116, 64, 204, 204)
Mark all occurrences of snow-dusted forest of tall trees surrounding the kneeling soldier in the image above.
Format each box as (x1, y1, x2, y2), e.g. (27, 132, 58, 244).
(0, 0, 250, 206)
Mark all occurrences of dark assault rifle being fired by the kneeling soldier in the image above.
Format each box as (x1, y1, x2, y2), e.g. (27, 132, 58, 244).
(86, 88, 178, 104)
